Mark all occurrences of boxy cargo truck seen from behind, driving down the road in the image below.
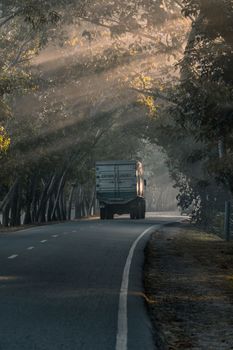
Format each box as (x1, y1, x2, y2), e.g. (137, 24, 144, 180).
(96, 160, 146, 220)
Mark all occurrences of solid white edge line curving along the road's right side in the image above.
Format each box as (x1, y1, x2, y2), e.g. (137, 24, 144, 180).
(115, 226, 155, 350)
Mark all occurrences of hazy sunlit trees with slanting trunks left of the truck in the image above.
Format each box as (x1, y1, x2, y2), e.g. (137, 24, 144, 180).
(0, 0, 187, 226)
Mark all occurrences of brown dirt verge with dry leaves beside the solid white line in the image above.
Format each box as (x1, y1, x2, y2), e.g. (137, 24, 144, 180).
(144, 224, 233, 350)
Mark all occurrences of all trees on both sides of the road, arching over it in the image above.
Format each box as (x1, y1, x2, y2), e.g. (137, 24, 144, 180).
(0, 0, 233, 225)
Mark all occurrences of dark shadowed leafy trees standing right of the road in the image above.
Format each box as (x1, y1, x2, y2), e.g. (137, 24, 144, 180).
(140, 0, 233, 226)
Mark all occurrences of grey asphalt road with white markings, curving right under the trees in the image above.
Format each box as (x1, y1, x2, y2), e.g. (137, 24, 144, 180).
(0, 213, 182, 350)
